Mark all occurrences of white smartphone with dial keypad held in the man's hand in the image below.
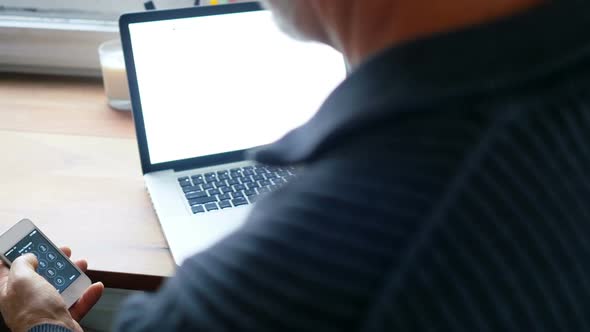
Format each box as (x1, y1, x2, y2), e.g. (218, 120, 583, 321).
(0, 219, 91, 308)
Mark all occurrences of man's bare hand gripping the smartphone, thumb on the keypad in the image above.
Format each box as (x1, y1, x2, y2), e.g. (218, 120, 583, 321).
(0, 247, 104, 332)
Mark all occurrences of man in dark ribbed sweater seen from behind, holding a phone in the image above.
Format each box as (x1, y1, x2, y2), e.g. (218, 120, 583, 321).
(0, 0, 590, 331)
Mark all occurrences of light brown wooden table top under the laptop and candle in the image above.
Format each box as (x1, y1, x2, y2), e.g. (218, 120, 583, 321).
(0, 74, 175, 290)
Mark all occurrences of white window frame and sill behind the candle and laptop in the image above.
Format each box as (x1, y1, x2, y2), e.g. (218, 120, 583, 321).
(0, 0, 252, 76)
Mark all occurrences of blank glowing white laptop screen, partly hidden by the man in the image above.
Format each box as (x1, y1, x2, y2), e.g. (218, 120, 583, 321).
(129, 10, 346, 164)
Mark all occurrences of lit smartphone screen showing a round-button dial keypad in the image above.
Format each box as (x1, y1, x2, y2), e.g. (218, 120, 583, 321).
(4, 229, 80, 293)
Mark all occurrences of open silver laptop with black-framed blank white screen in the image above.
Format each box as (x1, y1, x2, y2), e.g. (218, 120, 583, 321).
(119, 3, 346, 265)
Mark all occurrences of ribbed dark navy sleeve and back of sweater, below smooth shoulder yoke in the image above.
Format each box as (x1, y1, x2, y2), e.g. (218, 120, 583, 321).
(119, 91, 590, 331)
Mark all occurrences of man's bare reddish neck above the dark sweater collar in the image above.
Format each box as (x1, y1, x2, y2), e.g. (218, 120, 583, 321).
(327, 0, 545, 67)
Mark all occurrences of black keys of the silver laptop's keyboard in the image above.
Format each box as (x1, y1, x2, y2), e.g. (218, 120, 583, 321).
(178, 165, 295, 214)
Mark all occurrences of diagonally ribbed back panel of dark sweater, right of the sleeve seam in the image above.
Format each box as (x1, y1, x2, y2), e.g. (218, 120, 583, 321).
(364, 94, 590, 331)
